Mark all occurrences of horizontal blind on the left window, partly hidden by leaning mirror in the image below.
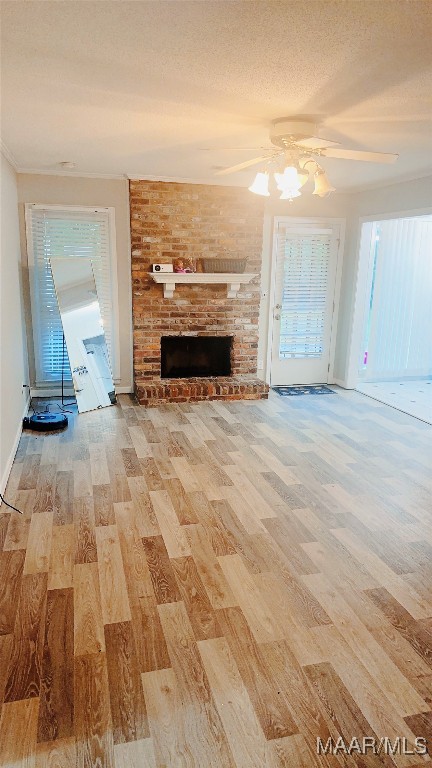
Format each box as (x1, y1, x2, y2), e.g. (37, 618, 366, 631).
(26, 205, 115, 386)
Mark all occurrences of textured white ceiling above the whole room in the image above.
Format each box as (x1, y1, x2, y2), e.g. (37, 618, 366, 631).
(1, 0, 432, 190)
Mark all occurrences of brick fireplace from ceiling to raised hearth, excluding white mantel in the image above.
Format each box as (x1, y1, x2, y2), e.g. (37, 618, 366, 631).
(130, 181, 268, 405)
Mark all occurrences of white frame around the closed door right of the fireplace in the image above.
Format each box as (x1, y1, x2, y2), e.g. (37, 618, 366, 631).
(265, 216, 346, 385)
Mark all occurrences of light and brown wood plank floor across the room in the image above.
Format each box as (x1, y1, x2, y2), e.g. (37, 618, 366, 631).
(0, 391, 432, 768)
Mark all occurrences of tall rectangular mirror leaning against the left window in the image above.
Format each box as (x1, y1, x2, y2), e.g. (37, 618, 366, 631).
(50, 258, 116, 413)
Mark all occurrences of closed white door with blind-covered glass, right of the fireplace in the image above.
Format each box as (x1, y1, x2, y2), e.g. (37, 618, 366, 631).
(270, 223, 339, 386)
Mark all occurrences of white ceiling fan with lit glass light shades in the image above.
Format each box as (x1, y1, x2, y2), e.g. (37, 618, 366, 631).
(215, 117, 398, 200)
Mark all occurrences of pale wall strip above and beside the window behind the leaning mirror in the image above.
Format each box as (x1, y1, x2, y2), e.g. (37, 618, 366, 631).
(18, 174, 132, 392)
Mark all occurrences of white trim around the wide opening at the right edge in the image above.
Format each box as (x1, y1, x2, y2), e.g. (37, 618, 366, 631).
(343, 207, 432, 389)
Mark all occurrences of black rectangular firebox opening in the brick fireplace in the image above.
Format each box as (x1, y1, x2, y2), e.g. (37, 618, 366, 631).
(161, 336, 233, 379)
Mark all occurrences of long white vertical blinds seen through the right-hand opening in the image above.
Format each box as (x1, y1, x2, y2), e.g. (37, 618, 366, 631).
(360, 216, 432, 381)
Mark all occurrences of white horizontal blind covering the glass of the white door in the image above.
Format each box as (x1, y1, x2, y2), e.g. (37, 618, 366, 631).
(278, 228, 332, 360)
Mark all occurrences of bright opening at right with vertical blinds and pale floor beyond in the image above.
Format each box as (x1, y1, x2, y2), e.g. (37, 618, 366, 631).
(357, 216, 432, 423)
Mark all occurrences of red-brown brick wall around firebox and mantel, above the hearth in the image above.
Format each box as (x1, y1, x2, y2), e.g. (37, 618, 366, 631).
(130, 181, 264, 384)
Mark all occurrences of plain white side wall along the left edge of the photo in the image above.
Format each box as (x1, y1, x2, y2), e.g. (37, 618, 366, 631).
(0, 155, 29, 493)
